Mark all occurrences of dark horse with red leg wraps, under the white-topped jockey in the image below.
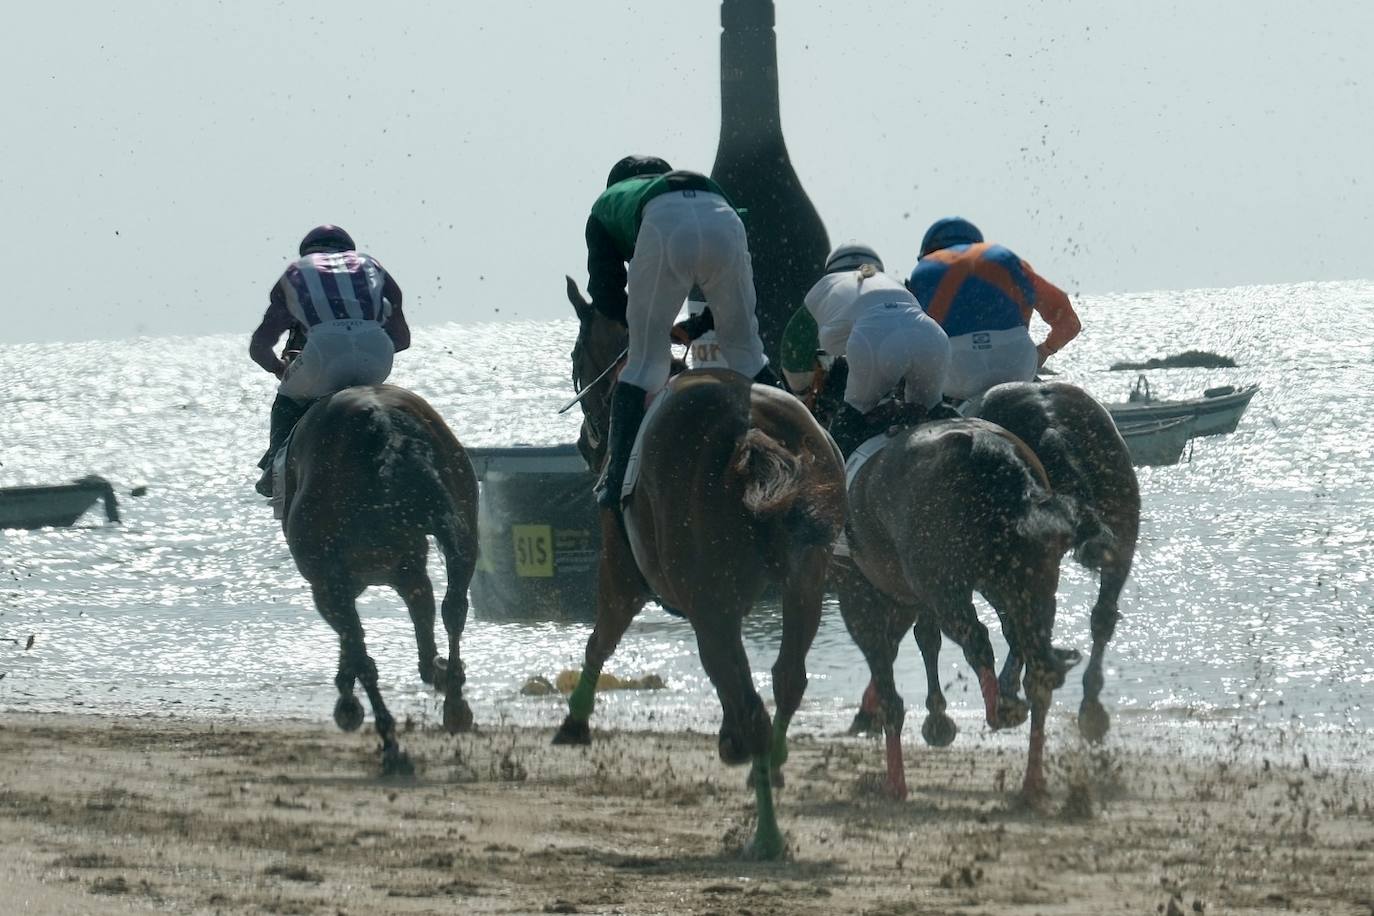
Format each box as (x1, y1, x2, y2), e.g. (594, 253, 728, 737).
(835, 420, 1077, 798)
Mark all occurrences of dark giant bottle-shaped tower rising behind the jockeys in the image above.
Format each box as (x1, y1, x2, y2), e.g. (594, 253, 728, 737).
(710, 0, 830, 365)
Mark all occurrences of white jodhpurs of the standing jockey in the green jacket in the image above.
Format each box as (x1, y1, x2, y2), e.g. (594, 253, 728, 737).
(620, 191, 768, 394)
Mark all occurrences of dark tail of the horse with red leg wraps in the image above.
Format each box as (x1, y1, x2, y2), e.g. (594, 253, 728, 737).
(969, 434, 1079, 547)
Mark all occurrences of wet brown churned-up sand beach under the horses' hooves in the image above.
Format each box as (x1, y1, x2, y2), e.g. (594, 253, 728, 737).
(0, 714, 1374, 916)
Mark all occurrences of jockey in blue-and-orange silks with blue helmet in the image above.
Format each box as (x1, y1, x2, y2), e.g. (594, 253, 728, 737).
(907, 217, 1081, 400)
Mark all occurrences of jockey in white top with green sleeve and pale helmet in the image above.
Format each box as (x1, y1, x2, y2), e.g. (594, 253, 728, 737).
(783, 242, 949, 457)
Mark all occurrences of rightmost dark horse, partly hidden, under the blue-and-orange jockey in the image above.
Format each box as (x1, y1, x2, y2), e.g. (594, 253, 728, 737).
(978, 382, 1140, 742)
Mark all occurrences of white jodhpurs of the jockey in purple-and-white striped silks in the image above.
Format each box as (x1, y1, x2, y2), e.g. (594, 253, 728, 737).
(278, 319, 396, 401)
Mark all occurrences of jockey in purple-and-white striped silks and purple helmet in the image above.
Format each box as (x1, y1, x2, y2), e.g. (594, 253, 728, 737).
(249, 225, 411, 496)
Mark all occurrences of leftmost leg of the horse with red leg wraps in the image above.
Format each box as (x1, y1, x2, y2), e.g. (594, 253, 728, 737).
(835, 567, 912, 798)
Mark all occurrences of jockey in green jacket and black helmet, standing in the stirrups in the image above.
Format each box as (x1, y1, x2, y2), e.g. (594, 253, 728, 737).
(587, 157, 776, 508)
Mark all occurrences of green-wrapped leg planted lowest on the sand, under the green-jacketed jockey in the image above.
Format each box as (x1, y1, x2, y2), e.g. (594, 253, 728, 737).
(692, 612, 783, 860)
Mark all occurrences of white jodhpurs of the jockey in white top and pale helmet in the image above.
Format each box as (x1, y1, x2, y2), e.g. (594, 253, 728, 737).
(845, 301, 949, 413)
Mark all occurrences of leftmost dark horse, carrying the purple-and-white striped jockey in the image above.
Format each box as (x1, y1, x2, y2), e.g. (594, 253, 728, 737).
(282, 385, 477, 773)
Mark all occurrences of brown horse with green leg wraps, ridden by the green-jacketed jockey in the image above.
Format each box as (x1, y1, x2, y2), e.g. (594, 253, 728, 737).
(554, 295, 845, 858)
